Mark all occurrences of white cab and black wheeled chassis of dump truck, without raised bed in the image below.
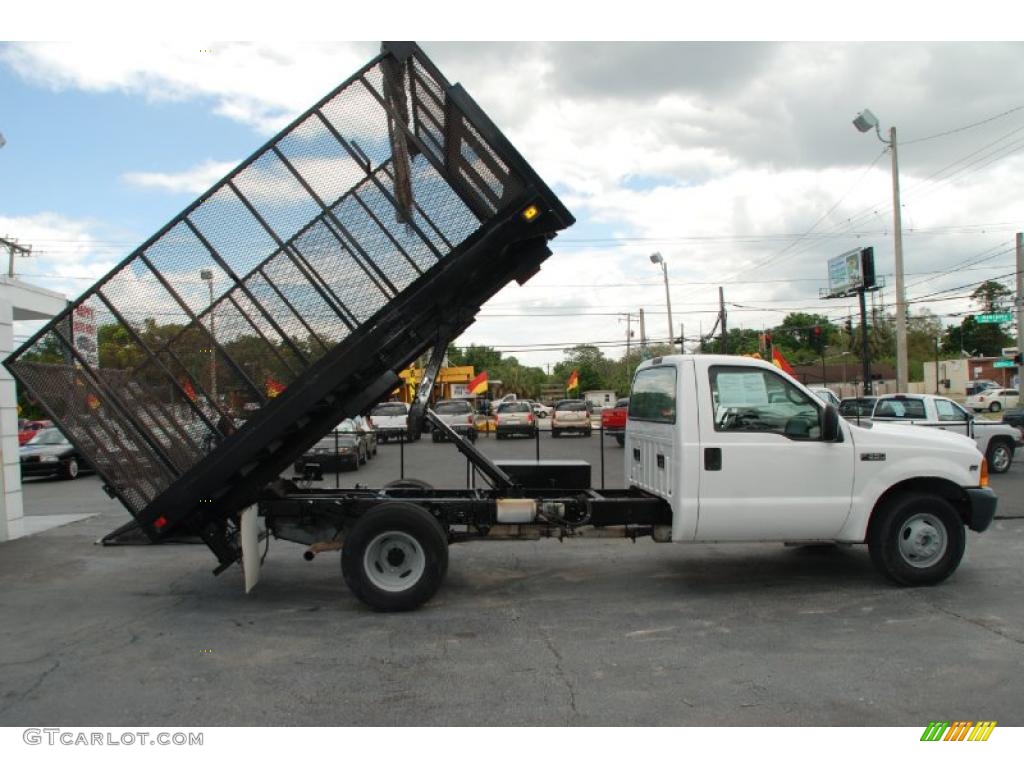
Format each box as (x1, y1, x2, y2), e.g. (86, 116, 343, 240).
(258, 355, 996, 610)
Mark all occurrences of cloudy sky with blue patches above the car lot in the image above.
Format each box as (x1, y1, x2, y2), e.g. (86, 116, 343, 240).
(0, 26, 1024, 365)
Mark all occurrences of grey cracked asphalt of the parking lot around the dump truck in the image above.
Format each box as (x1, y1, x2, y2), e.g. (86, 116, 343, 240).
(0, 434, 1024, 726)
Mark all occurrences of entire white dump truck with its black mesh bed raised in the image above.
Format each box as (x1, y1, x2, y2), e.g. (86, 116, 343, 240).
(5, 42, 996, 610)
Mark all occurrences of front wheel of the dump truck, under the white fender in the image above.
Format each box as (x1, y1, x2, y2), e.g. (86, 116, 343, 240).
(867, 494, 967, 587)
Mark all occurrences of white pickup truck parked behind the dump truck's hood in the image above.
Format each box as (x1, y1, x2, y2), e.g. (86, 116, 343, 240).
(870, 394, 1021, 474)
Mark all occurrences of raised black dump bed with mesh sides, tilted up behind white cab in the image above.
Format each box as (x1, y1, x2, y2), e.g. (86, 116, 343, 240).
(5, 43, 573, 565)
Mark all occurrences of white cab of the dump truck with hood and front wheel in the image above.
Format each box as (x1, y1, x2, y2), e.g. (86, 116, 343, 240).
(625, 355, 994, 583)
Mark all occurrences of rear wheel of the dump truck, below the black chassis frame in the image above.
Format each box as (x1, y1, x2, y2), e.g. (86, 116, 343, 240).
(341, 502, 449, 611)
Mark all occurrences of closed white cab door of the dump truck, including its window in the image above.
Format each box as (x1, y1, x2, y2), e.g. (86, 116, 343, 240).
(696, 366, 855, 541)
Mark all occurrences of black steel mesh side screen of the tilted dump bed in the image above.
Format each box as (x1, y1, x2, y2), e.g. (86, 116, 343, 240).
(7, 52, 522, 512)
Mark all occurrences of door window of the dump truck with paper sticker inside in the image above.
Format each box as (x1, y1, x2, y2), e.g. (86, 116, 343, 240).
(709, 366, 821, 440)
